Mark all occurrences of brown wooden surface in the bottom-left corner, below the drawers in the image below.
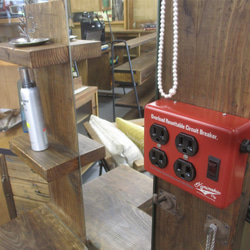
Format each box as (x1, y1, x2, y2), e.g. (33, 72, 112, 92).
(0, 205, 87, 249)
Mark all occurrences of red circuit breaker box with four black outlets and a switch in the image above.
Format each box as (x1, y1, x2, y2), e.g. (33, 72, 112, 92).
(144, 99, 250, 208)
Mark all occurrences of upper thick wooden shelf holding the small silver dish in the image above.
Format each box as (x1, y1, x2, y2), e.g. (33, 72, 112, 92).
(0, 40, 101, 68)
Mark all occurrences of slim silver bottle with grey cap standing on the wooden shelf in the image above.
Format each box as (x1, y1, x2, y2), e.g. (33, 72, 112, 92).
(19, 67, 48, 151)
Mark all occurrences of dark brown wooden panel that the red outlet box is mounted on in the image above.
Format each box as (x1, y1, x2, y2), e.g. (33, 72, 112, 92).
(153, 0, 250, 249)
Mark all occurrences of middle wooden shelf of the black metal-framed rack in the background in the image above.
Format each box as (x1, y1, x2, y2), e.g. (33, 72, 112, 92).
(114, 50, 156, 85)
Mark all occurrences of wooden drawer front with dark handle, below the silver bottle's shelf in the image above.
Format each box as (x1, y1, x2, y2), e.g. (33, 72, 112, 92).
(10, 177, 49, 202)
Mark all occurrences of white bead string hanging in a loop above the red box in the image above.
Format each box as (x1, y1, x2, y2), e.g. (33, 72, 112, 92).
(157, 0, 178, 98)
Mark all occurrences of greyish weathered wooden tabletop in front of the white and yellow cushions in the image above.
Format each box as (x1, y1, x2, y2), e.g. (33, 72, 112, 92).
(83, 166, 152, 249)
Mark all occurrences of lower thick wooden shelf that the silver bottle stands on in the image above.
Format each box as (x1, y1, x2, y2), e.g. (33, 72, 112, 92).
(10, 134, 105, 182)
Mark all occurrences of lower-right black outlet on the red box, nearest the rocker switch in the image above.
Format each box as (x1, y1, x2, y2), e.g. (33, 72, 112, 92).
(174, 159, 196, 181)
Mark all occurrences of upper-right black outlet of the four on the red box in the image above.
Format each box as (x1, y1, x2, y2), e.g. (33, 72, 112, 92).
(175, 133, 198, 156)
